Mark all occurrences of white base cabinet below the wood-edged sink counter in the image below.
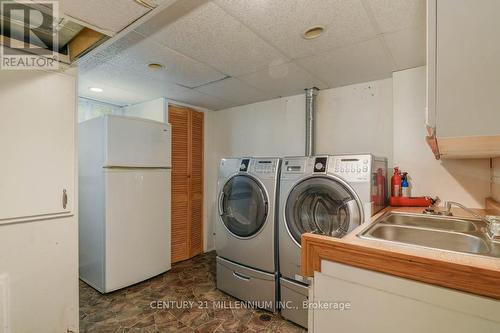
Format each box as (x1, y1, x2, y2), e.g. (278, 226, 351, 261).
(309, 261, 500, 333)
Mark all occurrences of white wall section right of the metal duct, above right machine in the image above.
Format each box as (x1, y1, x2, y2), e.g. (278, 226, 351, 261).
(316, 79, 393, 165)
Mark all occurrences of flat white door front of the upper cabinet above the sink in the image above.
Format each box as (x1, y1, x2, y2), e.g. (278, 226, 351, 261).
(436, 0, 500, 137)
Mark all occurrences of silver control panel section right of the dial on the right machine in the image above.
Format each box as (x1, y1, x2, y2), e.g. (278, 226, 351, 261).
(329, 155, 372, 182)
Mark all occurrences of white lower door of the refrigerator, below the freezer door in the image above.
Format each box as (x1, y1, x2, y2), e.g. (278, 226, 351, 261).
(105, 169, 171, 292)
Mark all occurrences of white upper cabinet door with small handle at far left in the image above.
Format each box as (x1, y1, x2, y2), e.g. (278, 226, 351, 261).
(0, 71, 76, 223)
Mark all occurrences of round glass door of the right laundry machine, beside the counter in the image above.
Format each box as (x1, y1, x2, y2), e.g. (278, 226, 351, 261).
(285, 177, 361, 245)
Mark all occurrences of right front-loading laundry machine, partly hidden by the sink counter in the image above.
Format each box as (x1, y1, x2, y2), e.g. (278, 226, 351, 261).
(279, 154, 387, 327)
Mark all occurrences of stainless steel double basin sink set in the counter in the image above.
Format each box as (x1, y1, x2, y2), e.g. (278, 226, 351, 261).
(358, 212, 500, 258)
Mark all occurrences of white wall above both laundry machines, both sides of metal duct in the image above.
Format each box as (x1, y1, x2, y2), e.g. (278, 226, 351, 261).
(211, 79, 392, 158)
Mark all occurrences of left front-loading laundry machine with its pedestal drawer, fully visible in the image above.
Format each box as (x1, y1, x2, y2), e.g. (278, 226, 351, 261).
(215, 158, 280, 311)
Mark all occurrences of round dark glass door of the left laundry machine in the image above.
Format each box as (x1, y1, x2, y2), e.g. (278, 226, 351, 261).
(219, 175, 268, 237)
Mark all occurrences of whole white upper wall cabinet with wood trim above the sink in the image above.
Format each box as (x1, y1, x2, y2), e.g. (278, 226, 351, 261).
(426, 0, 500, 158)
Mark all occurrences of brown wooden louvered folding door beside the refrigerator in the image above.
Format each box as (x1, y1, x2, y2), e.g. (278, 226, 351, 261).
(168, 105, 204, 262)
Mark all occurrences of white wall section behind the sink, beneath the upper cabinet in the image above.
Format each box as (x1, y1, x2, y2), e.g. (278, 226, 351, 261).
(393, 67, 490, 208)
